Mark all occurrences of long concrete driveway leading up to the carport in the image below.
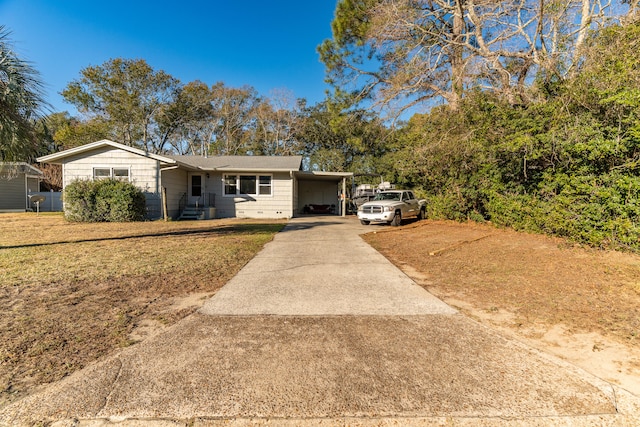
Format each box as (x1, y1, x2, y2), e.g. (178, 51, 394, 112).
(0, 217, 640, 426)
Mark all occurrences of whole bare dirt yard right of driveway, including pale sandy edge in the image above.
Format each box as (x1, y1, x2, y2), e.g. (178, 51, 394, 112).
(363, 221, 640, 395)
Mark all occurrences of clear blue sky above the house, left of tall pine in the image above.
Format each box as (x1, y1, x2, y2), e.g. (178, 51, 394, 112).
(0, 0, 336, 114)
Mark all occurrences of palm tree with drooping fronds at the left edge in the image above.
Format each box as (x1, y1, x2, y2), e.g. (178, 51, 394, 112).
(0, 25, 48, 161)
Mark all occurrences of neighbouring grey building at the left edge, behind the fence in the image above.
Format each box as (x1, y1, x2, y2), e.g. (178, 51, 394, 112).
(0, 162, 43, 212)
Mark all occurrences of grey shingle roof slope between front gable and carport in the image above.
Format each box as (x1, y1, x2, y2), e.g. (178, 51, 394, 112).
(165, 155, 302, 171)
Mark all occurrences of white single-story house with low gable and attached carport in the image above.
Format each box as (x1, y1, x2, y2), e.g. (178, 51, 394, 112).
(37, 140, 353, 219)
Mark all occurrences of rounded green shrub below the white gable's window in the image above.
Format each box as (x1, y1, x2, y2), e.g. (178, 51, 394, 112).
(62, 179, 146, 222)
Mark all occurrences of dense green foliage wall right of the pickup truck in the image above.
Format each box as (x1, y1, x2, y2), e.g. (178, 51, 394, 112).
(388, 25, 640, 250)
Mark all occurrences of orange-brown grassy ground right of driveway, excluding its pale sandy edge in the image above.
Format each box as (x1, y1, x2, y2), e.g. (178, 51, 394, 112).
(365, 221, 640, 349)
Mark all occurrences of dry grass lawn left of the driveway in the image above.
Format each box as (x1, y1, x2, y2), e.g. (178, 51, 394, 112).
(0, 213, 286, 407)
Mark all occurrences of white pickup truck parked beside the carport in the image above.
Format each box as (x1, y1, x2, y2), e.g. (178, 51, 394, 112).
(358, 190, 426, 226)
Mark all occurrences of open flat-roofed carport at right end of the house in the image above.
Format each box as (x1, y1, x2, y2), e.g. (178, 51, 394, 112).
(294, 171, 353, 216)
